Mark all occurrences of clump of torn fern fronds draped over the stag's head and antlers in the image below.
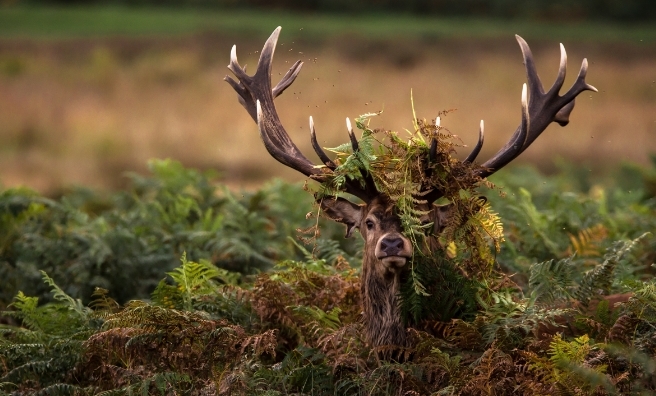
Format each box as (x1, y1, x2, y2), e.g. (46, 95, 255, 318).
(316, 112, 503, 320)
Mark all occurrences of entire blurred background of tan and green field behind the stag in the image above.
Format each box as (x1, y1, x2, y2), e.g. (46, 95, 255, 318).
(0, 0, 656, 195)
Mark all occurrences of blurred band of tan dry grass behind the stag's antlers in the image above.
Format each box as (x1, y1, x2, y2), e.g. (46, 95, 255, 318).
(0, 30, 656, 191)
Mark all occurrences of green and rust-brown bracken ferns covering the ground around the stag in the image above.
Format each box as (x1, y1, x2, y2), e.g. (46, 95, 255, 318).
(0, 157, 656, 395)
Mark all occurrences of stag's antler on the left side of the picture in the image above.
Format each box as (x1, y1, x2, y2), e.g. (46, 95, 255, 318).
(225, 27, 377, 202)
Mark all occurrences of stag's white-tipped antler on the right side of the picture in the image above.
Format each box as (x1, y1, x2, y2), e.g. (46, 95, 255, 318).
(467, 35, 597, 177)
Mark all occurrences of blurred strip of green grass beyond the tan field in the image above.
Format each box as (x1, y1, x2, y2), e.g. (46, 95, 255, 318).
(0, 6, 656, 44)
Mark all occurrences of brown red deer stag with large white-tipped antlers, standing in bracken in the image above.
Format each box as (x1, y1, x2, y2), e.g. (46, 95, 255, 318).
(225, 27, 596, 347)
